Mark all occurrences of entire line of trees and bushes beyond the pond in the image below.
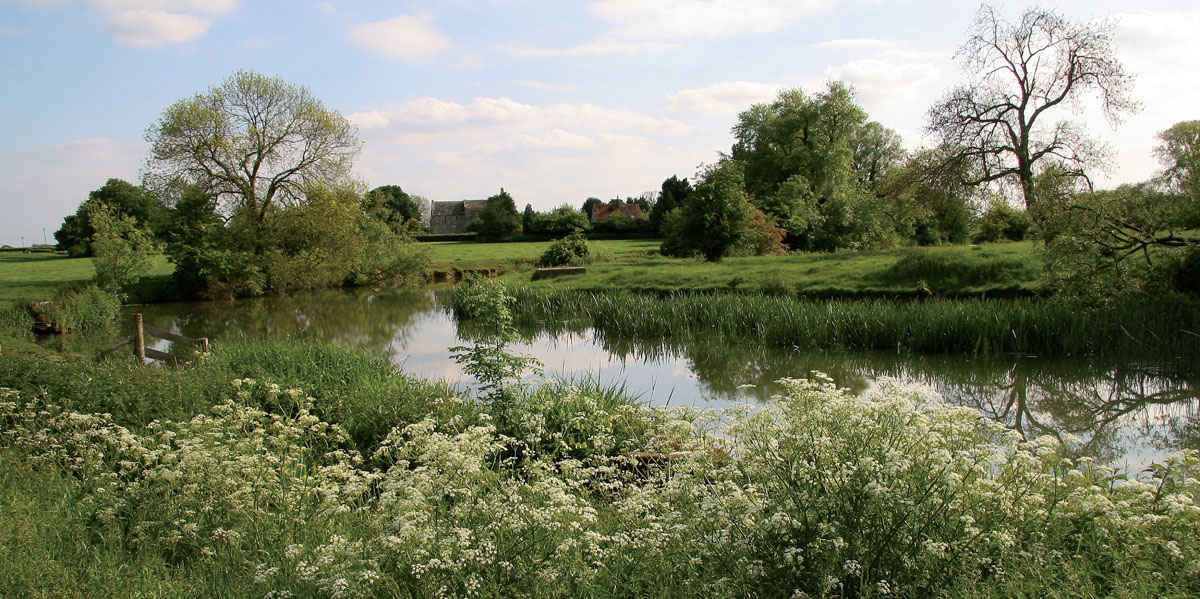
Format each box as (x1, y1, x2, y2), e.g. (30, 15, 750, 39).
(55, 6, 1200, 302)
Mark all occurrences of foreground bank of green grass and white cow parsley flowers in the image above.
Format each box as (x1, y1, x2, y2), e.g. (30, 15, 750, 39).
(0, 342, 1200, 598)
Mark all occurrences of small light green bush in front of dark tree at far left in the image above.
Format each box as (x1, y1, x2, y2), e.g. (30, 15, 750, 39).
(88, 204, 157, 298)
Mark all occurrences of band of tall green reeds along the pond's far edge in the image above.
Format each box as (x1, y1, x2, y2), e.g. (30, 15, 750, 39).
(501, 287, 1200, 360)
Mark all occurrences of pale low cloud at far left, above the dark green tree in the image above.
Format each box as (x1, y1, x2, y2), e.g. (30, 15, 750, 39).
(0, 138, 146, 245)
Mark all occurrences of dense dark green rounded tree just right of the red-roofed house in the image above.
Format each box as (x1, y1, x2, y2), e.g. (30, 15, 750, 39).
(661, 160, 751, 262)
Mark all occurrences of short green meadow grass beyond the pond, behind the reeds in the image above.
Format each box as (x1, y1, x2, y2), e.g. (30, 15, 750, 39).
(0, 239, 1043, 301)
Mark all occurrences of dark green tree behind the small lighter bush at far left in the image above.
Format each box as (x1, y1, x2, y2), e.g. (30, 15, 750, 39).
(54, 179, 166, 257)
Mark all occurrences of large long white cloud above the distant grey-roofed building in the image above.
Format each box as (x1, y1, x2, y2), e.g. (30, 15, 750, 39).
(350, 97, 700, 210)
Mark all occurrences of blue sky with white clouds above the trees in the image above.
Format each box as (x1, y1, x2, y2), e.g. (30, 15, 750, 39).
(0, 0, 1200, 245)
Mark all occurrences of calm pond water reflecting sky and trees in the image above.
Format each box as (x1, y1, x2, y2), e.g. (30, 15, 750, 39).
(60, 292, 1200, 474)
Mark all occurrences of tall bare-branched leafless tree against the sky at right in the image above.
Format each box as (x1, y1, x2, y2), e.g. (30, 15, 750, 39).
(928, 6, 1136, 217)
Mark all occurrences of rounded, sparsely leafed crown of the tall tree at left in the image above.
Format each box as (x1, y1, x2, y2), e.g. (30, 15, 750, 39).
(146, 71, 360, 229)
